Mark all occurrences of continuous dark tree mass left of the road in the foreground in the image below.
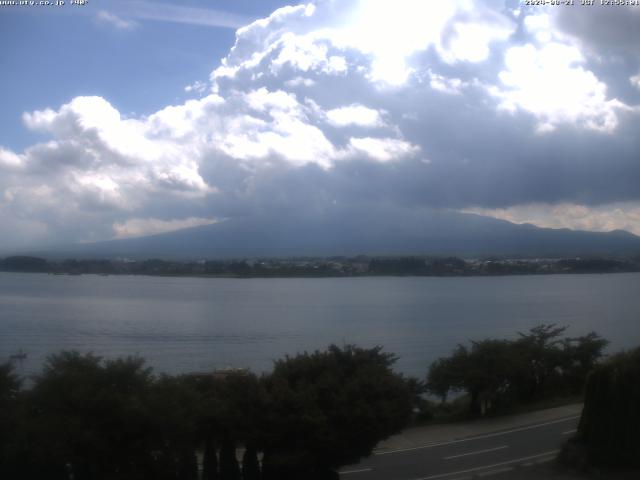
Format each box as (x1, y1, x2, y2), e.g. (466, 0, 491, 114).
(0, 346, 412, 480)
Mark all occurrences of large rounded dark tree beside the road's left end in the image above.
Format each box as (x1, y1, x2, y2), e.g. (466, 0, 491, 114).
(263, 345, 411, 479)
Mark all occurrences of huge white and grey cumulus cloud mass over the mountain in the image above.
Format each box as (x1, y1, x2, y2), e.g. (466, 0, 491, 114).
(0, 0, 640, 248)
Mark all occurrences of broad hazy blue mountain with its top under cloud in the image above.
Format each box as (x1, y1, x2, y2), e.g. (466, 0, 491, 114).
(26, 210, 640, 259)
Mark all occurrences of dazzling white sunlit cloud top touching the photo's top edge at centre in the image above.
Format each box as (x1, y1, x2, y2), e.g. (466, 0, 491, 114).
(211, 0, 516, 86)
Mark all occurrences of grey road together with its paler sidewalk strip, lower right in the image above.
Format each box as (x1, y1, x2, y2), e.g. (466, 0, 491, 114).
(340, 405, 582, 480)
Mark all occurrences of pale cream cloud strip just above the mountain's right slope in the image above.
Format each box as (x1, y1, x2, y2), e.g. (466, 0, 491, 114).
(465, 202, 640, 235)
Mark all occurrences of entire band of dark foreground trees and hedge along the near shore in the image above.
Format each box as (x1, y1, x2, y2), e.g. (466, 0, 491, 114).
(0, 325, 640, 480)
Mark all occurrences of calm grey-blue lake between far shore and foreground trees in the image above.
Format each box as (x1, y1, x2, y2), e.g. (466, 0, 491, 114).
(0, 272, 640, 378)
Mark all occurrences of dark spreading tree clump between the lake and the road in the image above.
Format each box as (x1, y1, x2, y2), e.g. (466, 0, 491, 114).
(427, 325, 608, 415)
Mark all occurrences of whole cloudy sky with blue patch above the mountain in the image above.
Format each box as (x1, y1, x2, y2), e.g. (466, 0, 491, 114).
(0, 0, 640, 249)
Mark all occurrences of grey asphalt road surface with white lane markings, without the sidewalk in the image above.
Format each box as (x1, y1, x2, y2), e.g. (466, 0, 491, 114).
(340, 415, 580, 480)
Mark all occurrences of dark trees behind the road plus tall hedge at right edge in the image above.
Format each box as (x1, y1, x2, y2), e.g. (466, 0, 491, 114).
(426, 325, 640, 470)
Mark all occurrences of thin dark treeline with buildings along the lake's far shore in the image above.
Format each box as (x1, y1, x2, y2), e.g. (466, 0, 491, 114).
(0, 255, 640, 278)
